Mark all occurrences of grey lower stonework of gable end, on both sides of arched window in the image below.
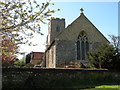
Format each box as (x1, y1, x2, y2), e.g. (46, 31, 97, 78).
(56, 40, 101, 67)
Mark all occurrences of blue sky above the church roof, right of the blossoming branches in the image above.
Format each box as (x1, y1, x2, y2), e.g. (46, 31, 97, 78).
(50, 2, 118, 37)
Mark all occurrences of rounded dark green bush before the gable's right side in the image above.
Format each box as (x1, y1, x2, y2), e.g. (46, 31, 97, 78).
(88, 44, 115, 68)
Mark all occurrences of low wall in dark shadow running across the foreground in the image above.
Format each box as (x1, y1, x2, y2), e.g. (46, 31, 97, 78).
(2, 68, 120, 89)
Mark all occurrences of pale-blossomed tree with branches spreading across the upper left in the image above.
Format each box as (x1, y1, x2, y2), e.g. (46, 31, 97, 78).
(0, 0, 59, 61)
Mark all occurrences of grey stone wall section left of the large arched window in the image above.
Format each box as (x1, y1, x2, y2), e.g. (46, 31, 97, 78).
(56, 40, 76, 67)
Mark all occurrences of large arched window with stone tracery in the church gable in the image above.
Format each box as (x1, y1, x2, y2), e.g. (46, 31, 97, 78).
(76, 31, 89, 60)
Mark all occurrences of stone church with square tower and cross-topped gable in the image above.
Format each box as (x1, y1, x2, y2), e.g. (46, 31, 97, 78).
(45, 8, 109, 68)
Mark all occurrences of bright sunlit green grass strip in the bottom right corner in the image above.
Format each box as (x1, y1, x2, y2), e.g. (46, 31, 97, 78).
(83, 85, 120, 90)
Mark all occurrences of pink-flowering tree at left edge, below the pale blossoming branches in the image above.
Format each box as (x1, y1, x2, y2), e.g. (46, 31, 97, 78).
(1, 37, 19, 67)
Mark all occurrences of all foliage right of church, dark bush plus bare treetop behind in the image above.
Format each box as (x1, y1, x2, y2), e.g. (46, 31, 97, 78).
(88, 35, 120, 71)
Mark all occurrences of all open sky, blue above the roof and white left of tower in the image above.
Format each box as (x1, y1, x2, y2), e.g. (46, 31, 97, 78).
(19, 2, 118, 58)
